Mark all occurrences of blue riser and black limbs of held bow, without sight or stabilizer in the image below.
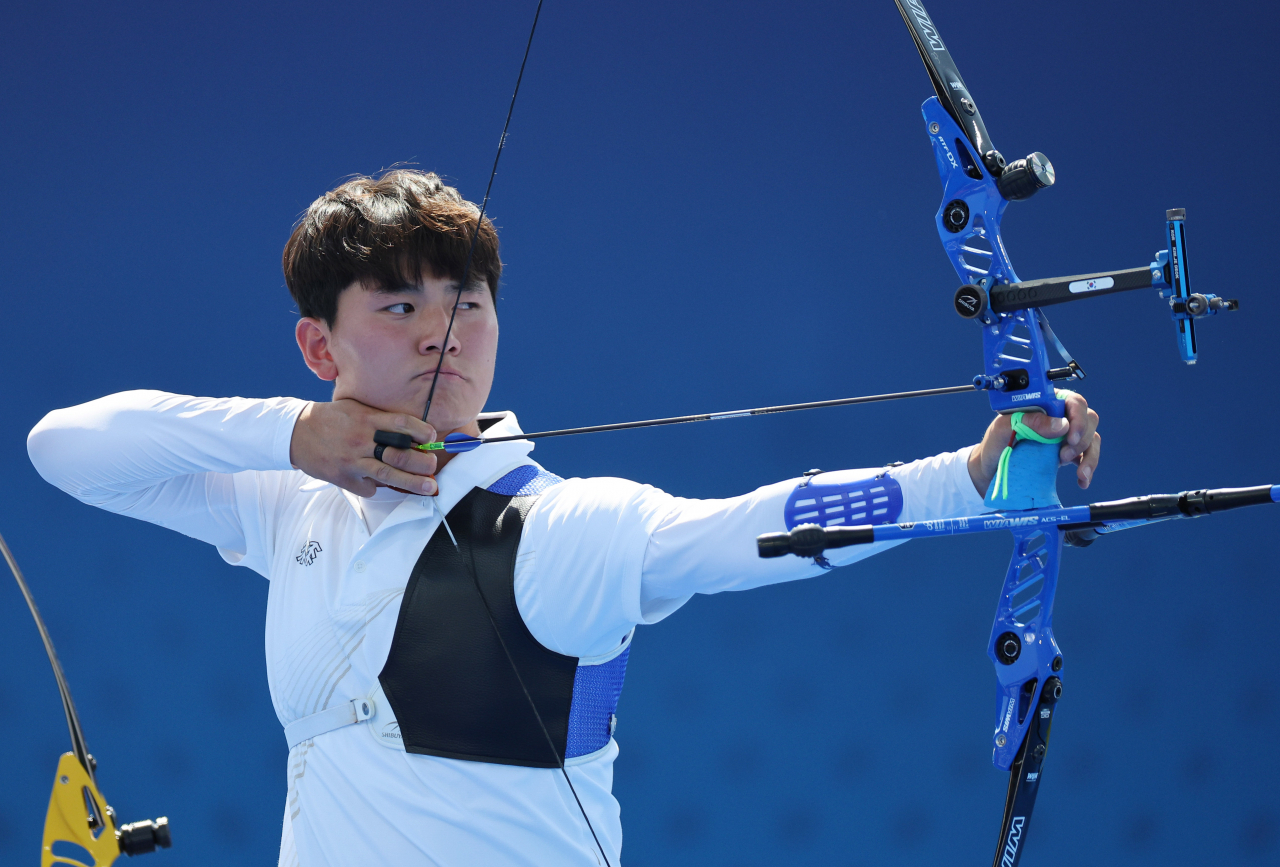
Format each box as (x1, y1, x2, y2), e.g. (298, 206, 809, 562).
(916, 11, 1083, 867)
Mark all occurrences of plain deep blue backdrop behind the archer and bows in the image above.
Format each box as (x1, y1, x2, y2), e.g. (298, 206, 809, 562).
(0, 0, 1280, 867)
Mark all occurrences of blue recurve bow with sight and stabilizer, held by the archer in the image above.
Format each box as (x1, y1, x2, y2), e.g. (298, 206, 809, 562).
(758, 0, 1280, 867)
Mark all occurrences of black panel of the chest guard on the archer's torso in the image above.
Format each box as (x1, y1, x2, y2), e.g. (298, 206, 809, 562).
(378, 488, 577, 768)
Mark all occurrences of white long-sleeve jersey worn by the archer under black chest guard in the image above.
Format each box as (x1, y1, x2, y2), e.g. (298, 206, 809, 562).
(27, 391, 983, 867)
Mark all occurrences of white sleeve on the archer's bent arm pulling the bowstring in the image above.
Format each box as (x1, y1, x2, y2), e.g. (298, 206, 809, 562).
(27, 391, 307, 558)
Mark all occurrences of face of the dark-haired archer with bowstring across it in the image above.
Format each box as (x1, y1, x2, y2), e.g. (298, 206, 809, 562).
(297, 275, 498, 437)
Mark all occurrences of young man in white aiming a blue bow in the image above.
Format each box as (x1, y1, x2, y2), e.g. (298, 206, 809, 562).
(28, 170, 1100, 867)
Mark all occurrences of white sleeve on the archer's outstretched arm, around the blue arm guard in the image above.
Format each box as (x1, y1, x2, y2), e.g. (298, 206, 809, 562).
(516, 448, 983, 657)
